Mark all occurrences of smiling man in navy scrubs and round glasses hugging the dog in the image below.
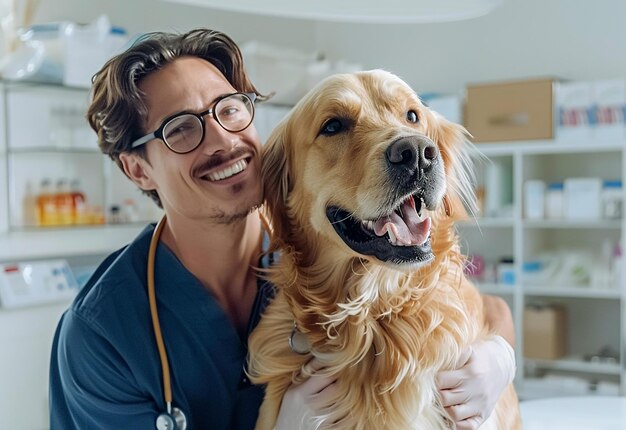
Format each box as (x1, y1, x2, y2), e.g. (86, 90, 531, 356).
(50, 30, 514, 430)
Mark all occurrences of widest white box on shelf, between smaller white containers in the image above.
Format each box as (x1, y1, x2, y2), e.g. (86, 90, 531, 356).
(563, 178, 602, 220)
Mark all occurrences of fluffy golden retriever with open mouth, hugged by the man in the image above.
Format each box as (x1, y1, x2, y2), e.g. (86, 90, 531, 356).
(249, 70, 520, 430)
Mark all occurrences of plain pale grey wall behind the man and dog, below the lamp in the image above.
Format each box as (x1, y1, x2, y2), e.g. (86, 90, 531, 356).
(37, 0, 626, 92)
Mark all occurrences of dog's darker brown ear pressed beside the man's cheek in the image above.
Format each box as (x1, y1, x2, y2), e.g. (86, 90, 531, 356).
(261, 122, 291, 244)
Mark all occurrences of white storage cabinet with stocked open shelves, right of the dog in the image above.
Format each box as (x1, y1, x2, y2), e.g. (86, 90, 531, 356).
(458, 141, 626, 398)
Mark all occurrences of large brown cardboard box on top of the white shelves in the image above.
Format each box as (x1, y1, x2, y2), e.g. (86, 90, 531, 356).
(465, 79, 554, 143)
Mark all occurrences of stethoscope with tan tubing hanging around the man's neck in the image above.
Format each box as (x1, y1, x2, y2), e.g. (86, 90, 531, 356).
(148, 215, 187, 430)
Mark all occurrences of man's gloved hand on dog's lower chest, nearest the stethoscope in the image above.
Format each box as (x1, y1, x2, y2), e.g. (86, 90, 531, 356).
(275, 359, 335, 430)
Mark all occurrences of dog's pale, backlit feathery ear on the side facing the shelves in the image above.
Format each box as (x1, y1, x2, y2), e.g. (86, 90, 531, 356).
(429, 112, 477, 219)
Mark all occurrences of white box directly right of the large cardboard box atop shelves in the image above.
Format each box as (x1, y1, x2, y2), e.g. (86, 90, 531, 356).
(555, 81, 594, 143)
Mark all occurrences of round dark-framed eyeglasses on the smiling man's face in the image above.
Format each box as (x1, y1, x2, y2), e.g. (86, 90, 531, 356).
(131, 93, 256, 154)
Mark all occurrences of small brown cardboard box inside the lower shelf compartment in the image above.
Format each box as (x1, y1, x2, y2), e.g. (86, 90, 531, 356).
(524, 306, 567, 360)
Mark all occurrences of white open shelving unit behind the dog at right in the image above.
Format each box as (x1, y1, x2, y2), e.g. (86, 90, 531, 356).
(458, 139, 626, 398)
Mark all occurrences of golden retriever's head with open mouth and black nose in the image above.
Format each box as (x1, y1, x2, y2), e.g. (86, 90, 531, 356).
(262, 70, 472, 268)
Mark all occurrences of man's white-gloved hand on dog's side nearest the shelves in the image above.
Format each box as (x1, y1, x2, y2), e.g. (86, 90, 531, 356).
(436, 335, 515, 430)
